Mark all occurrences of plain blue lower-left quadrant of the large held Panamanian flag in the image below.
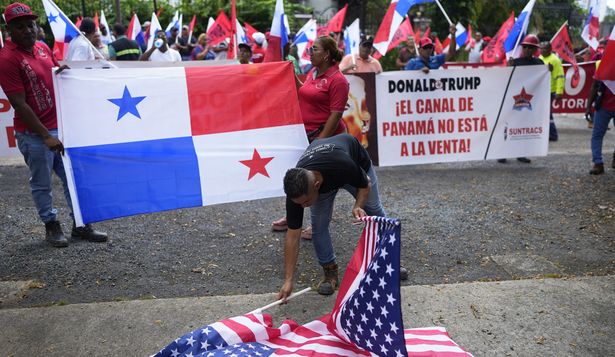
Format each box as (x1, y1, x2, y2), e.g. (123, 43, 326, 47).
(66, 137, 203, 222)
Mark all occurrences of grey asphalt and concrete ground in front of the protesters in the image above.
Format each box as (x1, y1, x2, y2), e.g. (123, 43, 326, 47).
(0, 116, 615, 356)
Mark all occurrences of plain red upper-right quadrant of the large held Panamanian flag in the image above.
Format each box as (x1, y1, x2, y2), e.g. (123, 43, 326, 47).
(186, 62, 303, 136)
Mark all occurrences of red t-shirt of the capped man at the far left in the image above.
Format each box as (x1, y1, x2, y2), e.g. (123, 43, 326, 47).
(0, 41, 59, 132)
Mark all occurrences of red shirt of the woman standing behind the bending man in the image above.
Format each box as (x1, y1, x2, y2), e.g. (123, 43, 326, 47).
(299, 65, 350, 134)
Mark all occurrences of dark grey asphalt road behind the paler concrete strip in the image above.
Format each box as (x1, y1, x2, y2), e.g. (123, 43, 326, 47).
(0, 116, 615, 355)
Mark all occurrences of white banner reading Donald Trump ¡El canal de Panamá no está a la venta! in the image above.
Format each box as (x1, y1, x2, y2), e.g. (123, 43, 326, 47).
(376, 66, 550, 166)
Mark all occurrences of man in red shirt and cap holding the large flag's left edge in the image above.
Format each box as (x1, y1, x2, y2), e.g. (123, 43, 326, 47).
(0, 3, 107, 247)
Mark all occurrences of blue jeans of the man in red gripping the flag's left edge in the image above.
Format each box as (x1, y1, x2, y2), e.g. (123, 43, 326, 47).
(15, 130, 72, 223)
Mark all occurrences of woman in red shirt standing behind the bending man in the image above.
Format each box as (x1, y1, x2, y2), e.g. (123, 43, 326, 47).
(271, 36, 350, 235)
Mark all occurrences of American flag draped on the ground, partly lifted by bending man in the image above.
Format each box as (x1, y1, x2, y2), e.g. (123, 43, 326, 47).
(154, 217, 471, 357)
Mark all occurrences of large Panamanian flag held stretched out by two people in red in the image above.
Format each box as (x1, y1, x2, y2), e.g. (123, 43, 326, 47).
(54, 62, 308, 225)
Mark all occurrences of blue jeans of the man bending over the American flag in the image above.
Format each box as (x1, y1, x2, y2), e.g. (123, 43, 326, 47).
(310, 166, 386, 265)
